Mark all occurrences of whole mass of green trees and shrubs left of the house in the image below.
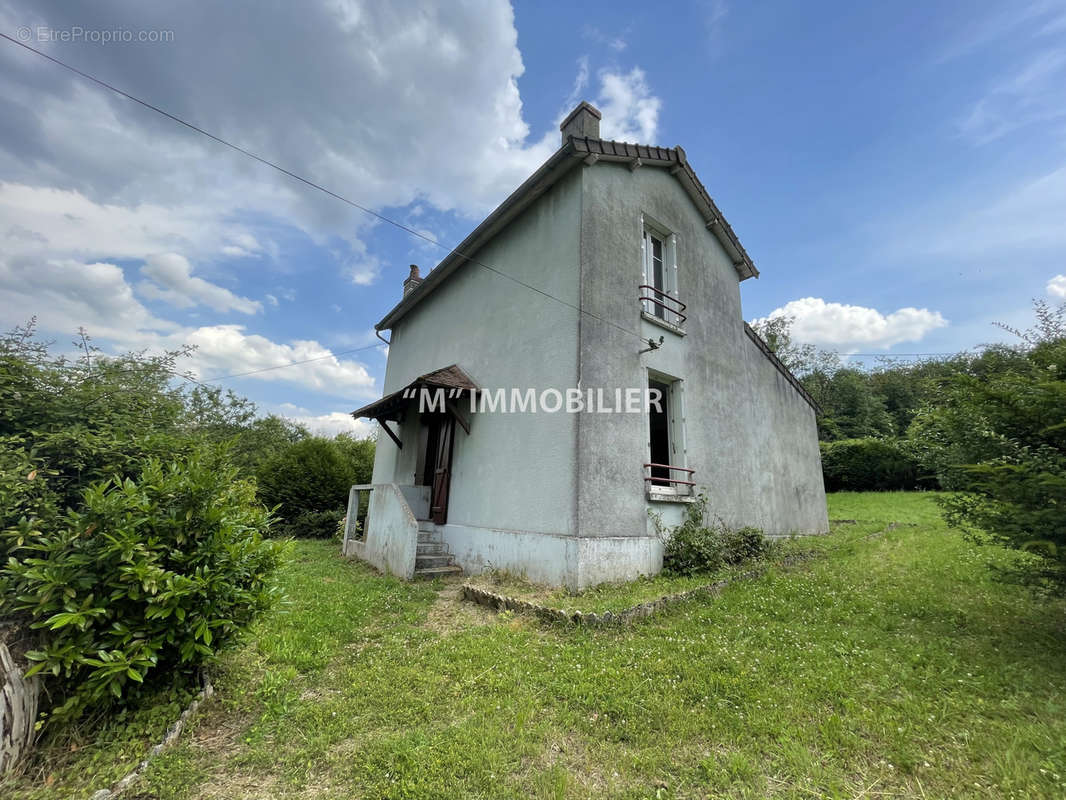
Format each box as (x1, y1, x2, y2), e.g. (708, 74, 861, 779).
(0, 325, 374, 746)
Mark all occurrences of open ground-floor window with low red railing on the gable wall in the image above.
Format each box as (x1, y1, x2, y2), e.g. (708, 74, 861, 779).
(644, 372, 695, 495)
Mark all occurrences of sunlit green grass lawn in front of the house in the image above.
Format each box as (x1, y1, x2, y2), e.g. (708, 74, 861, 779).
(0, 493, 1066, 800)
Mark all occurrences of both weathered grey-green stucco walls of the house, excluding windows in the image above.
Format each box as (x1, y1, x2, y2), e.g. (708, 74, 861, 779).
(373, 154, 827, 588)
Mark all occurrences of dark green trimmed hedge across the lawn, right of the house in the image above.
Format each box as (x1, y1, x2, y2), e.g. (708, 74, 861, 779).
(821, 436, 935, 492)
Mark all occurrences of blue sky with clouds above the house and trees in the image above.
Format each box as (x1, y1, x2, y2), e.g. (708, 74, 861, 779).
(0, 0, 1066, 434)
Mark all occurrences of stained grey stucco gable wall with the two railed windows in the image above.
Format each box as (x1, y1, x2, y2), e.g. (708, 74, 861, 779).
(578, 163, 827, 558)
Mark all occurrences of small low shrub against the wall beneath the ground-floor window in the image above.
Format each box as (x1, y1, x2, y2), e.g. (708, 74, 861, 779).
(663, 495, 766, 575)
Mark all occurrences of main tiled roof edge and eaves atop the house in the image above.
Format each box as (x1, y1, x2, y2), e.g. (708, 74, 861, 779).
(375, 137, 759, 331)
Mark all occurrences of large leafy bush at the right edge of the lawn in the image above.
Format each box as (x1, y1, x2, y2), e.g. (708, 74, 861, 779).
(914, 313, 1066, 594)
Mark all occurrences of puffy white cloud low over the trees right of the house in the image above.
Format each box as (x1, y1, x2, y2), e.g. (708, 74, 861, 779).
(757, 298, 948, 352)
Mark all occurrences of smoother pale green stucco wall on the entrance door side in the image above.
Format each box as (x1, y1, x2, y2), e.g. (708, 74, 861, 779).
(374, 170, 581, 546)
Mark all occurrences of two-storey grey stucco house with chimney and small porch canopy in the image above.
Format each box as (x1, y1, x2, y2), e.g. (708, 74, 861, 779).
(343, 102, 828, 589)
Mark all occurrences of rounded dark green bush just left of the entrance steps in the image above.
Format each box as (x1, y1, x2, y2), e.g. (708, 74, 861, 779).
(258, 436, 374, 538)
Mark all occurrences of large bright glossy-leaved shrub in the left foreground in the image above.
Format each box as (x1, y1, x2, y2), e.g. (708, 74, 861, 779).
(0, 451, 282, 721)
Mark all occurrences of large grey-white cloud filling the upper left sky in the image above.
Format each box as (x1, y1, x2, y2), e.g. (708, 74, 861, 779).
(0, 0, 558, 231)
